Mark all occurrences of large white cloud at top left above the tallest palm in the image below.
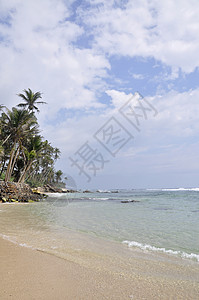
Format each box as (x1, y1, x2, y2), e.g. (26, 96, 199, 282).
(0, 0, 110, 114)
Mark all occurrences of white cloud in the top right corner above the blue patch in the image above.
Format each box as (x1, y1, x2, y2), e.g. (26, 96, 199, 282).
(82, 0, 199, 73)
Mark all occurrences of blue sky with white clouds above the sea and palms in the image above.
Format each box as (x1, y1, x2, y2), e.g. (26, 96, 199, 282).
(0, 0, 199, 189)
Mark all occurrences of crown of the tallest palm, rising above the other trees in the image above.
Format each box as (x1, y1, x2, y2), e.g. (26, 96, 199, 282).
(18, 89, 46, 112)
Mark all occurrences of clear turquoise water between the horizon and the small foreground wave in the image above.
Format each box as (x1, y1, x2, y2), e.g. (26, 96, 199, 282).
(0, 189, 199, 261)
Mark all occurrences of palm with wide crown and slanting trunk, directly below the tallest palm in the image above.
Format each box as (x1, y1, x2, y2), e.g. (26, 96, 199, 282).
(1, 107, 38, 182)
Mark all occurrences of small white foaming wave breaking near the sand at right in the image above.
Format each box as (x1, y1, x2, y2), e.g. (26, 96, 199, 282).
(122, 241, 199, 262)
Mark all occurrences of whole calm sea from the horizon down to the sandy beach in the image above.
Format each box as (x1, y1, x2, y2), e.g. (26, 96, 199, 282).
(0, 188, 199, 263)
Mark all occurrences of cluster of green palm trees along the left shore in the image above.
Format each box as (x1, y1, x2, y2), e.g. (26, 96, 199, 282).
(0, 89, 63, 187)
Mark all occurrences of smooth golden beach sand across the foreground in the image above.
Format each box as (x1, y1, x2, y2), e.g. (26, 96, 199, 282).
(0, 238, 199, 300)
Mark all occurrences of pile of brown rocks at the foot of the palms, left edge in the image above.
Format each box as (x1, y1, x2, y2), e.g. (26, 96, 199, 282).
(0, 181, 43, 202)
